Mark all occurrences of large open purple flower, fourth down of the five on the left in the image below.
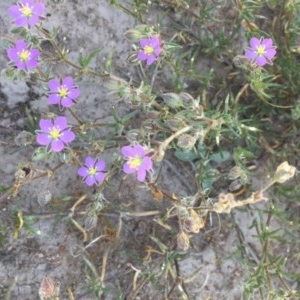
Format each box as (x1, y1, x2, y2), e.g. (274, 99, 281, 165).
(36, 117, 75, 152)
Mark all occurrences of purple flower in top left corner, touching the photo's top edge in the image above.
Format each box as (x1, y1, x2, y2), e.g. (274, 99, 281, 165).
(8, 0, 45, 27)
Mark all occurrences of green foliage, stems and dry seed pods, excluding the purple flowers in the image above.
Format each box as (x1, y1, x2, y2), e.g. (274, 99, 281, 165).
(0, 0, 300, 299)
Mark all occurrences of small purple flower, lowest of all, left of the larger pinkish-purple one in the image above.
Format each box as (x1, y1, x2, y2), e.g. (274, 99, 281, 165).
(77, 156, 105, 186)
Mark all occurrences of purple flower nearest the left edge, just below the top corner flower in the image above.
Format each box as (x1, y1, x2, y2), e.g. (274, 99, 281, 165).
(7, 40, 40, 70)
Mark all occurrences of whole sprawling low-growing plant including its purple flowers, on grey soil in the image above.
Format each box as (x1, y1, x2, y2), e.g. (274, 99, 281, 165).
(0, 0, 300, 299)
